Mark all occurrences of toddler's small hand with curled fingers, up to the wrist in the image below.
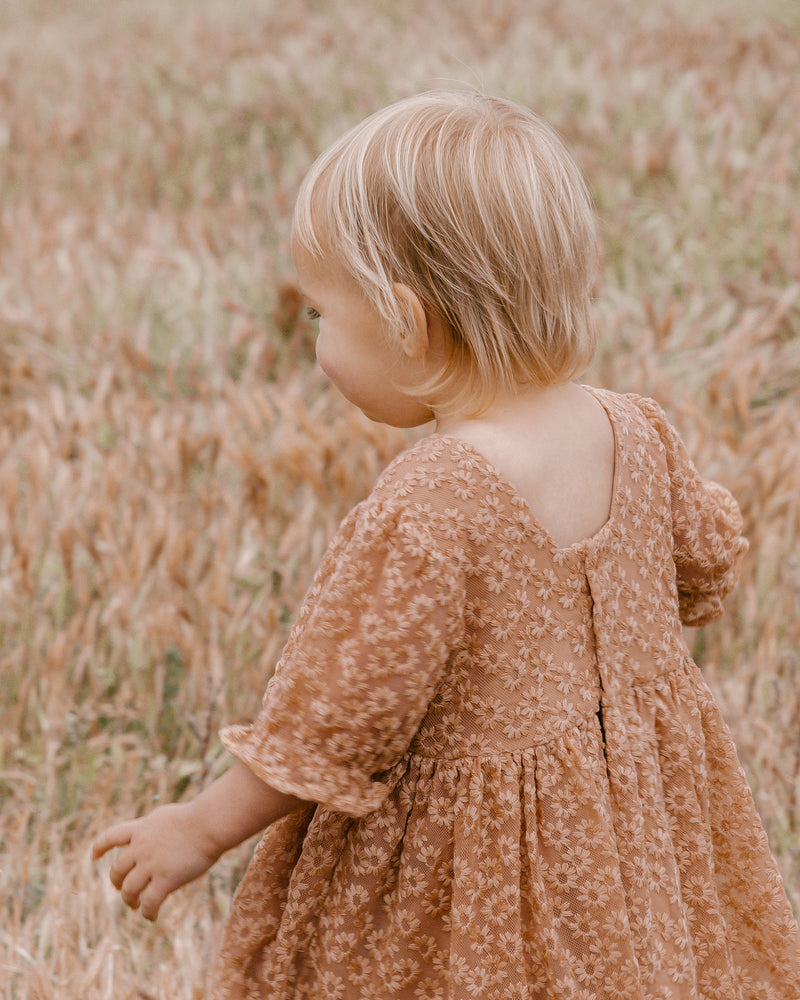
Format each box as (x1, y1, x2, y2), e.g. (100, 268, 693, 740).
(92, 803, 219, 920)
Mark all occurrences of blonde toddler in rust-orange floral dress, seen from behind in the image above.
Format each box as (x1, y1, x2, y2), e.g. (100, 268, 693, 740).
(94, 92, 800, 1000)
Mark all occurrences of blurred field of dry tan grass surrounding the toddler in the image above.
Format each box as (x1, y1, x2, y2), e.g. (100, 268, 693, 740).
(0, 0, 800, 1000)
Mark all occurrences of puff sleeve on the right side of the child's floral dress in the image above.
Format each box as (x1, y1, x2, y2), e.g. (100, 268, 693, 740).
(632, 396, 748, 625)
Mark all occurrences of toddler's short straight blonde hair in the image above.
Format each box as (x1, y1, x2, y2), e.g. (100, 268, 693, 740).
(293, 91, 599, 412)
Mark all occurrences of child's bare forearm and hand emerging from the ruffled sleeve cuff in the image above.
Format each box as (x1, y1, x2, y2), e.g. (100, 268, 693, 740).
(92, 761, 305, 920)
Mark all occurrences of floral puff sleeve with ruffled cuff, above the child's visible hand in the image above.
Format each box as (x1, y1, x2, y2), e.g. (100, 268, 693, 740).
(220, 486, 465, 816)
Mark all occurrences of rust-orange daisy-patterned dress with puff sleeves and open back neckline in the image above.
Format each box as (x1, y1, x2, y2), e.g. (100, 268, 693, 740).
(210, 389, 800, 1000)
